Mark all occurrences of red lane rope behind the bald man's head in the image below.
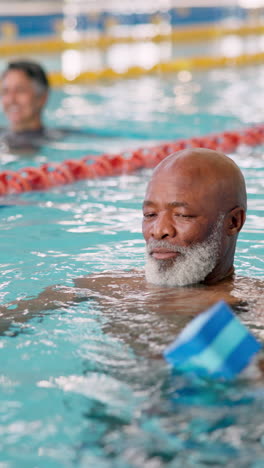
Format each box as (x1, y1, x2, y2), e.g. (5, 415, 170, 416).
(0, 124, 264, 196)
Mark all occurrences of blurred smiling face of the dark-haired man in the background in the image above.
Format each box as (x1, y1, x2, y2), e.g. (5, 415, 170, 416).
(1, 70, 46, 131)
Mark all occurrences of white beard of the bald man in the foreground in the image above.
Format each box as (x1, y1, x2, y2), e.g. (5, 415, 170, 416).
(145, 215, 223, 287)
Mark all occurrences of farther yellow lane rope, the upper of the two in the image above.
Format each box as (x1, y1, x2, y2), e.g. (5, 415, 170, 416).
(0, 24, 264, 56)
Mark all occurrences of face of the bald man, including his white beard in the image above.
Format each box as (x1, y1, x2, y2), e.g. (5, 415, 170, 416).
(142, 163, 223, 286)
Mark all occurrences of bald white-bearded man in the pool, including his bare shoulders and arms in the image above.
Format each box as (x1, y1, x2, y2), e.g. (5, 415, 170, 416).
(2, 148, 264, 344)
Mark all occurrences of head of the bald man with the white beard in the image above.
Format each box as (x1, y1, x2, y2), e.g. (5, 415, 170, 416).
(143, 149, 247, 286)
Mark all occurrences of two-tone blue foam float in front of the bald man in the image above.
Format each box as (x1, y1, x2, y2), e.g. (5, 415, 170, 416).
(163, 301, 262, 379)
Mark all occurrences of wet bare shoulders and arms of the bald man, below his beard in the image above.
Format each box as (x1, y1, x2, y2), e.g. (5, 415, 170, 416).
(0, 270, 264, 357)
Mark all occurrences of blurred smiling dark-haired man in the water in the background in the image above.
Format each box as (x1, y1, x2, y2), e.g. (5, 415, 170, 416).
(0, 60, 109, 155)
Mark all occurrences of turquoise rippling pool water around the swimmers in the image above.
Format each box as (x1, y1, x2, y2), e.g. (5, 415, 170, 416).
(0, 66, 264, 468)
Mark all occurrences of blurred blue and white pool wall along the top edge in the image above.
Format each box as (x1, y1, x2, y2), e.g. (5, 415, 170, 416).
(0, 2, 252, 41)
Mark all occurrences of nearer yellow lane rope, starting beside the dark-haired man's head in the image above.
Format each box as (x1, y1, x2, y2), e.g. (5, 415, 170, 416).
(49, 52, 264, 86)
